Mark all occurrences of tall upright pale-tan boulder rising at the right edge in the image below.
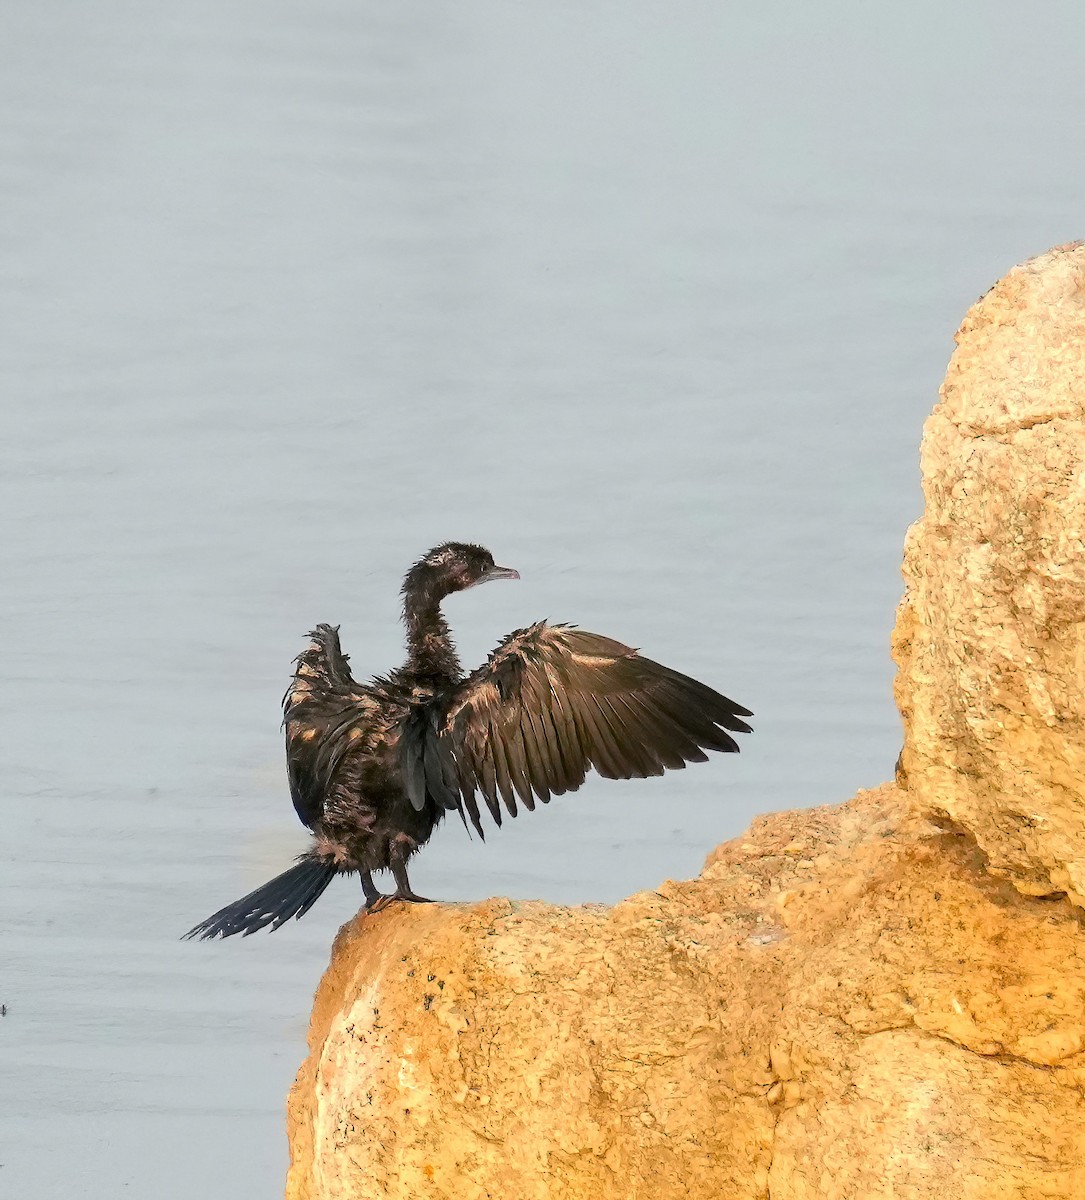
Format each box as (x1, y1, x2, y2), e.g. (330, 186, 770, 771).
(894, 242, 1085, 905)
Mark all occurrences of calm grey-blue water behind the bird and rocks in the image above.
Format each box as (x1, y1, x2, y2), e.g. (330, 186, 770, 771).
(0, 0, 1085, 1200)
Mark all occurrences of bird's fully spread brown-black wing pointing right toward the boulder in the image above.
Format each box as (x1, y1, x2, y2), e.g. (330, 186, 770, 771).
(402, 622, 753, 834)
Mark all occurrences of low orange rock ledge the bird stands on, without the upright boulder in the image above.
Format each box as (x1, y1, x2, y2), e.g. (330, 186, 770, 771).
(287, 785, 1085, 1200)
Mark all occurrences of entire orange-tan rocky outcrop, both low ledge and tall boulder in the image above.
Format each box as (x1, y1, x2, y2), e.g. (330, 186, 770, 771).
(287, 247, 1085, 1200)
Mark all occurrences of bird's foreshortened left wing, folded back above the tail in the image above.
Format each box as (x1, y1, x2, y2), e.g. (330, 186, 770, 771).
(282, 625, 376, 826)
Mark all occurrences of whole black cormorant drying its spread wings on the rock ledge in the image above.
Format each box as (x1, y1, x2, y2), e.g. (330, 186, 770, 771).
(185, 542, 753, 937)
